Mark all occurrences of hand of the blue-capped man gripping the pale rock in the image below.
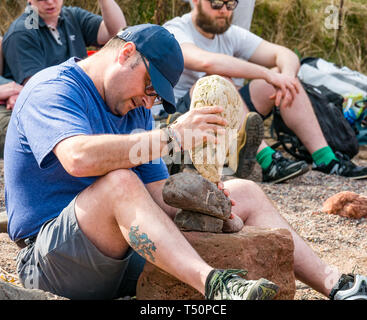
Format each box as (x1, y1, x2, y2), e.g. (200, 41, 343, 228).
(170, 106, 227, 150)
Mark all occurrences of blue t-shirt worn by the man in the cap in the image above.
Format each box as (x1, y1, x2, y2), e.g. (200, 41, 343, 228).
(4, 58, 168, 241)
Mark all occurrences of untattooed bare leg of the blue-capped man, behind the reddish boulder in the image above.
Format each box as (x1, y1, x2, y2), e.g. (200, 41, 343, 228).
(224, 179, 340, 296)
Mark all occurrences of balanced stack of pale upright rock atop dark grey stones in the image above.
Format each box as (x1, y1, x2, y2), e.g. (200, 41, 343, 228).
(163, 75, 244, 233)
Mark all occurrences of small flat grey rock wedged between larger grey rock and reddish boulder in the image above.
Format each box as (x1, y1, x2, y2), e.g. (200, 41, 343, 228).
(174, 210, 223, 233)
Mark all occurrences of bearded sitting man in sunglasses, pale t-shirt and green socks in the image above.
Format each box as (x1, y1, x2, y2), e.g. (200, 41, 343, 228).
(164, 0, 367, 183)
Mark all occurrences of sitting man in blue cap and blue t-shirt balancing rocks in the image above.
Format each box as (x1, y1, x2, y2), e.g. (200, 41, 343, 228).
(4, 25, 367, 300)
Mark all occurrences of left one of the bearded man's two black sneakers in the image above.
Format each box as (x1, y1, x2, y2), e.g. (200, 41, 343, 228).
(262, 151, 308, 183)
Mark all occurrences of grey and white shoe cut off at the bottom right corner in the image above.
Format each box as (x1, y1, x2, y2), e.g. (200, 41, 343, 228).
(329, 274, 367, 300)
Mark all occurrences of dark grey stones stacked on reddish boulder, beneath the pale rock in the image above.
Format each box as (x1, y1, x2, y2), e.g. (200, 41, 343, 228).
(163, 172, 243, 233)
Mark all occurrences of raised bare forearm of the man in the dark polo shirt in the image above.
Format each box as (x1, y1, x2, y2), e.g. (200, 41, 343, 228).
(99, 0, 126, 37)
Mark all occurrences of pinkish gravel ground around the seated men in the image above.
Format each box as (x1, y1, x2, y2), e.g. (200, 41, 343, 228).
(0, 142, 367, 300)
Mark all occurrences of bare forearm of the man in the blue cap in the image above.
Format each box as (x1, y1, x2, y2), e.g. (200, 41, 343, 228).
(54, 130, 168, 177)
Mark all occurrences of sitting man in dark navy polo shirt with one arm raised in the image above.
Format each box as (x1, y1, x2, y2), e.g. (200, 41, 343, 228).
(3, 0, 126, 84)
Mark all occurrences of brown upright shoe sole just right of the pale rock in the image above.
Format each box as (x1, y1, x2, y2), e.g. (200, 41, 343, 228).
(235, 112, 264, 179)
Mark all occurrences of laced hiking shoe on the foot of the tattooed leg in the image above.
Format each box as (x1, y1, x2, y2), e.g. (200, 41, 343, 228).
(205, 269, 279, 300)
